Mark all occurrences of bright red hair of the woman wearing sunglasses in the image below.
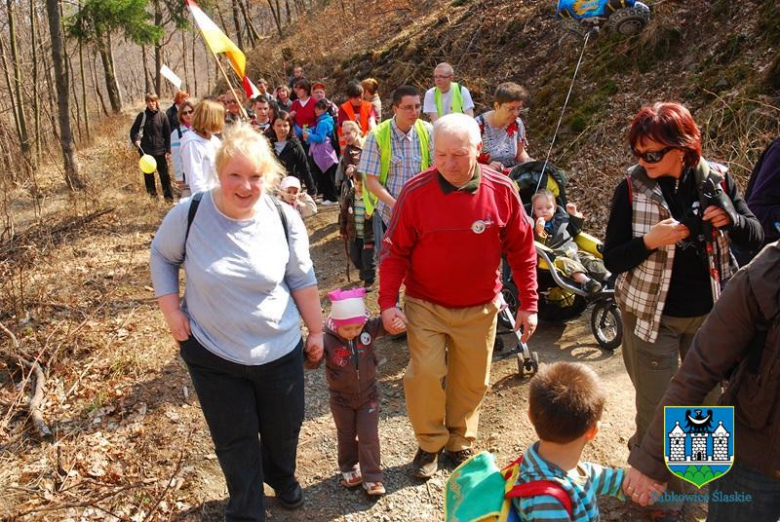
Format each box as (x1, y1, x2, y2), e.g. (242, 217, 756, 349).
(628, 102, 701, 167)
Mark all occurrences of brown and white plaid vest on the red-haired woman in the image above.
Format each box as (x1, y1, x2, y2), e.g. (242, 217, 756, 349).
(615, 158, 736, 343)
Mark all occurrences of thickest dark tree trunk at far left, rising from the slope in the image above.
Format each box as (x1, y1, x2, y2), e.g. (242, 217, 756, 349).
(46, 0, 84, 190)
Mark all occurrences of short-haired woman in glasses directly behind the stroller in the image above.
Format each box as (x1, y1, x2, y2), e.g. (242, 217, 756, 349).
(476, 82, 531, 172)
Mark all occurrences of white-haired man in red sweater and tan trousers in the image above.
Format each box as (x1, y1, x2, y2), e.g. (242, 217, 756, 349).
(379, 114, 537, 479)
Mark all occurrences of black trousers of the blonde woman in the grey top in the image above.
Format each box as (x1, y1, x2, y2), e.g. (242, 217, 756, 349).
(180, 337, 304, 522)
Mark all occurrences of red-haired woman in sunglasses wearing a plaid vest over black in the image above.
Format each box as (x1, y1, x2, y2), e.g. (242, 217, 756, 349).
(604, 103, 763, 521)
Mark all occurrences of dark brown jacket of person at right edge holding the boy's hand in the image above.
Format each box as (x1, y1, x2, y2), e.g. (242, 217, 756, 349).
(628, 242, 780, 481)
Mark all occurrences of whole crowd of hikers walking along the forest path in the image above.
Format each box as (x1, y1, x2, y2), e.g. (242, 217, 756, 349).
(140, 63, 780, 522)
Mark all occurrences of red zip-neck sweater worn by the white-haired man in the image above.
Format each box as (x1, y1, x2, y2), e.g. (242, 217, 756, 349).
(379, 166, 537, 312)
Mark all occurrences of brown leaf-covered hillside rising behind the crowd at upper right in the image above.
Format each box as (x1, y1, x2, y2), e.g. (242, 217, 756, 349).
(249, 0, 780, 223)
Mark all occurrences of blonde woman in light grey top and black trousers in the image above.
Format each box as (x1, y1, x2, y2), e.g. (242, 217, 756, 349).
(151, 123, 323, 520)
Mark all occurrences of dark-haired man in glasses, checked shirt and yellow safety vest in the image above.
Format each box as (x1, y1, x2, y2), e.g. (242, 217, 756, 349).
(358, 85, 433, 253)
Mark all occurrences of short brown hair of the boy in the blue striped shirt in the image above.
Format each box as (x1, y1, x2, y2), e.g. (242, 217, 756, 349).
(528, 362, 607, 444)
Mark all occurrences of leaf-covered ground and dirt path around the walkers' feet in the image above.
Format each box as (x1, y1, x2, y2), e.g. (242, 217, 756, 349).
(0, 115, 704, 521)
